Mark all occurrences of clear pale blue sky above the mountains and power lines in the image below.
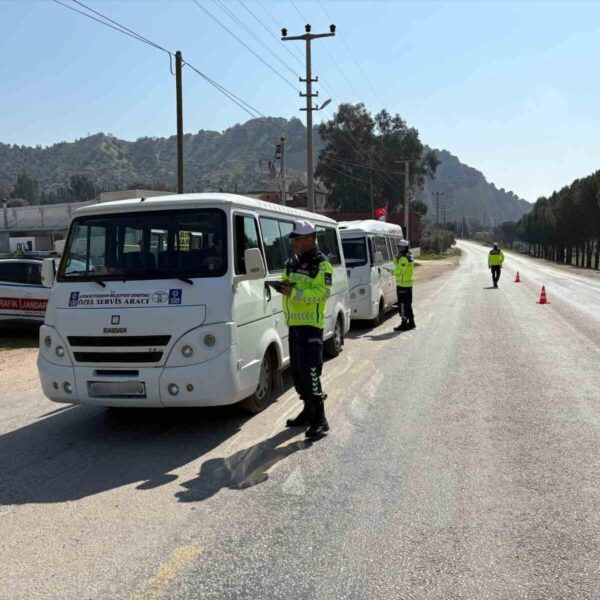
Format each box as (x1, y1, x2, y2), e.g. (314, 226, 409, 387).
(0, 0, 600, 201)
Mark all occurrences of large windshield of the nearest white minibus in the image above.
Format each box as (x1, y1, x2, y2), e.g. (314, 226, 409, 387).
(57, 209, 227, 281)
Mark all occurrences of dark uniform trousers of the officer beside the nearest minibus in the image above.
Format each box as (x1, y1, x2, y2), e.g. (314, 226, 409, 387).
(289, 325, 323, 400)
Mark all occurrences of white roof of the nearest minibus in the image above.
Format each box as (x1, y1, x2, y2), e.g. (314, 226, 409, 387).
(73, 193, 337, 225)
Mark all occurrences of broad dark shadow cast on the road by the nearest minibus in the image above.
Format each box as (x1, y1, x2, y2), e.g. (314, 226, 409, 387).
(0, 406, 249, 506)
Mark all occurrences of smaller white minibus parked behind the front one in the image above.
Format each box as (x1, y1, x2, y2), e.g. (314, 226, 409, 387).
(339, 219, 403, 325)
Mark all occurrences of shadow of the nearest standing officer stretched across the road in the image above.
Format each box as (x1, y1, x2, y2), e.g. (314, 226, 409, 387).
(175, 429, 311, 502)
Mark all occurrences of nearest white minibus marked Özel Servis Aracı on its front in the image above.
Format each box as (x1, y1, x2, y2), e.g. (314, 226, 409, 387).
(38, 193, 350, 412)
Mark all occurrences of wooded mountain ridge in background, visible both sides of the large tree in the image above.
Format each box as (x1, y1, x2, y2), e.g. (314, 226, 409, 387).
(0, 117, 531, 222)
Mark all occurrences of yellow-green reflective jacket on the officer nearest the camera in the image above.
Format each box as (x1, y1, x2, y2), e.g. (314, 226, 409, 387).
(281, 248, 333, 329)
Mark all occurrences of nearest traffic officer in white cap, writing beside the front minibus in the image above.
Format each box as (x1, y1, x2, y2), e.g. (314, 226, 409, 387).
(281, 221, 333, 439)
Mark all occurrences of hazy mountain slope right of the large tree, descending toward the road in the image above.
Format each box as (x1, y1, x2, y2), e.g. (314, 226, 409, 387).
(415, 150, 533, 223)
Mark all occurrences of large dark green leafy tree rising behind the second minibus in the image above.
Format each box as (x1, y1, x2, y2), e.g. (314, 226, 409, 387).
(315, 104, 439, 211)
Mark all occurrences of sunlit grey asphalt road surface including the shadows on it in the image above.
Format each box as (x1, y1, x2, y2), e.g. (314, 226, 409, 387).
(0, 243, 600, 600)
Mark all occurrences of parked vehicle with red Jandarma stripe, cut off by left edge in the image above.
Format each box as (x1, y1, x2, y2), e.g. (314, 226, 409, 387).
(0, 258, 50, 323)
